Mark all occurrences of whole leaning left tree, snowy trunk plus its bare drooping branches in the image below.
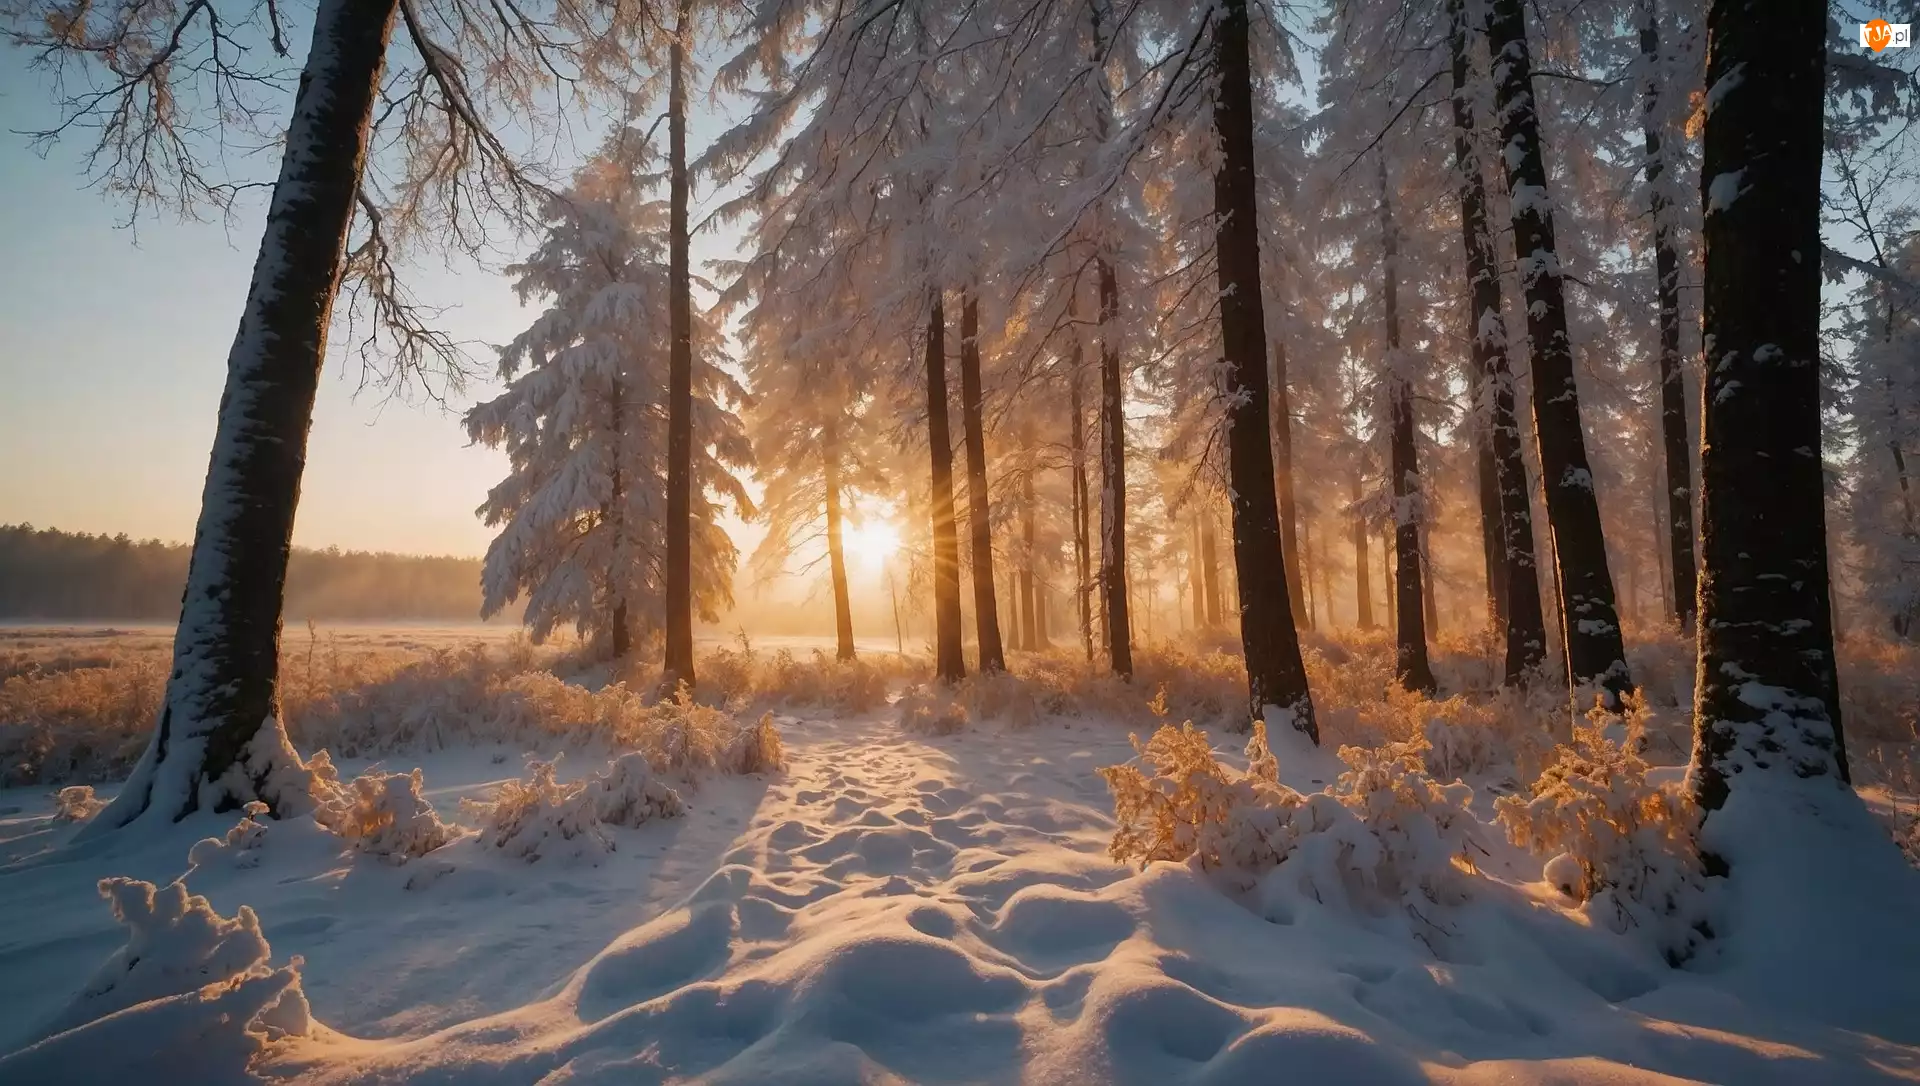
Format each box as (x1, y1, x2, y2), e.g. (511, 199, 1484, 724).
(6, 0, 639, 833)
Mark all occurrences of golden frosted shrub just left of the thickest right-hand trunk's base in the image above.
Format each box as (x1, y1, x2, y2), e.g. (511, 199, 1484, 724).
(1496, 720, 1703, 952)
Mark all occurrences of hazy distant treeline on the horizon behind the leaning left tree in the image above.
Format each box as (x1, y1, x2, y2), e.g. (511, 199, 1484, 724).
(0, 524, 511, 624)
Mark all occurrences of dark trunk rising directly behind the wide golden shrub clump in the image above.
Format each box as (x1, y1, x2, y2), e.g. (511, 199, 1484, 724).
(1213, 0, 1319, 743)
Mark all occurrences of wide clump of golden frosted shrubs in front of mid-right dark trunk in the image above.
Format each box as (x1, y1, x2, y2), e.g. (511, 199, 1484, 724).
(1100, 721, 1476, 911)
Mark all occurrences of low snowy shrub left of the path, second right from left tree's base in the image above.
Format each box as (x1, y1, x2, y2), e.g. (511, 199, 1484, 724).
(472, 752, 691, 863)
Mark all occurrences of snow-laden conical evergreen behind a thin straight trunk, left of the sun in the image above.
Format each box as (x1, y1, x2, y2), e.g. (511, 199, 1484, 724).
(465, 139, 753, 656)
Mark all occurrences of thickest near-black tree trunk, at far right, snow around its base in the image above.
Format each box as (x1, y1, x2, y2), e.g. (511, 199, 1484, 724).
(1692, 0, 1847, 823)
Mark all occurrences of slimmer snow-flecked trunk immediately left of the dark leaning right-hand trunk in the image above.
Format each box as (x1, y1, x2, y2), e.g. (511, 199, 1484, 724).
(1448, 0, 1548, 685)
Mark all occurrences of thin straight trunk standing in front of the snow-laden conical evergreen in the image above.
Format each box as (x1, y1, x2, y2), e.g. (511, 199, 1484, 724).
(660, 0, 693, 693)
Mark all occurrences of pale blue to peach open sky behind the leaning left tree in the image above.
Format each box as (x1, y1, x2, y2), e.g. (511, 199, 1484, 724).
(0, 37, 755, 555)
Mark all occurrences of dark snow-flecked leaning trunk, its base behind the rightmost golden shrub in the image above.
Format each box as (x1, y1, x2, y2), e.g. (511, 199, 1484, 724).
(1488, 0, 1634, 704)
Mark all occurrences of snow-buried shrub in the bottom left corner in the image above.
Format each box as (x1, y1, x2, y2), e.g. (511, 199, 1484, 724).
(42, 879, 311, 1040)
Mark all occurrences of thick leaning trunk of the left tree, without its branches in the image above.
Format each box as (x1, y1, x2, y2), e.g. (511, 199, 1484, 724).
(88, 0, 397, 833)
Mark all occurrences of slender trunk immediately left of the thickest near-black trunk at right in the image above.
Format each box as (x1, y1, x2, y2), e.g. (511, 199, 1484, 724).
(1640, 0, 1697, 629)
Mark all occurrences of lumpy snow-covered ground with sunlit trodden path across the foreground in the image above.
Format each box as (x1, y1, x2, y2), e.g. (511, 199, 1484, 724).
(0, 712, 1920, 1086)
